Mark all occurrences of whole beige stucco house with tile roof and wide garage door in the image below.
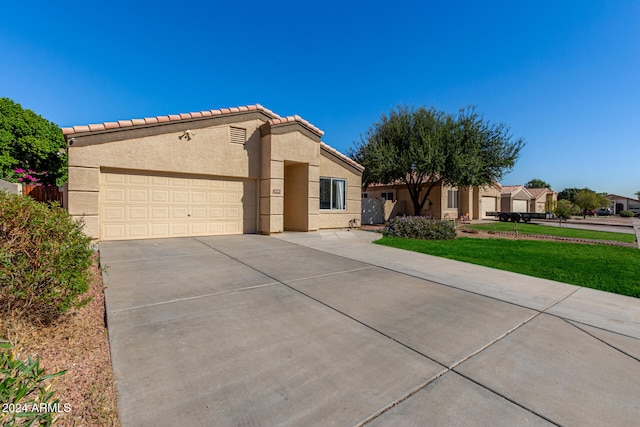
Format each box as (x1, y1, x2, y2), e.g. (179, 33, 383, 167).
(62, 105, 364, 240)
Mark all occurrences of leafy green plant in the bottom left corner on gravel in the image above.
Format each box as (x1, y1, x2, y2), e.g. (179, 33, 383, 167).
(0, 341, 66, 426)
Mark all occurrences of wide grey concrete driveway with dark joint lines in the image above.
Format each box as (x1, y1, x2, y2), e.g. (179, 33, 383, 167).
(100, 231, 640, 426)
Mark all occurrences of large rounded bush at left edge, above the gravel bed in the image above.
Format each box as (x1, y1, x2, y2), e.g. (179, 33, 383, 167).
(0, 191, 93, 324)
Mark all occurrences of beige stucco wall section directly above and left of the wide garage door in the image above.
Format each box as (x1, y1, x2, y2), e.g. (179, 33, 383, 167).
(68, 120, 263, 238)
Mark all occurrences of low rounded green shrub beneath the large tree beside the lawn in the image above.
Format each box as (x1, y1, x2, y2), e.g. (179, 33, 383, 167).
(382, 216, 456, 240)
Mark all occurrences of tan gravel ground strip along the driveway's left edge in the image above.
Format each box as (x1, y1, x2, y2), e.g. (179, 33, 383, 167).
(0, 256, 120, 427)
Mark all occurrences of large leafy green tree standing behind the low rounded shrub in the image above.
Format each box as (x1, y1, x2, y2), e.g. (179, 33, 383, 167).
(349, 106, 524, 215)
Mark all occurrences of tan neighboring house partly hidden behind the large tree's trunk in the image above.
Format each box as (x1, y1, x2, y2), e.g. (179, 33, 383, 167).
(362, 183, 500, 224)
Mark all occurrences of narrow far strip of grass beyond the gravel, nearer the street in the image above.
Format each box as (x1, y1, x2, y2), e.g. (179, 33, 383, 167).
(467, 222, 636, 243)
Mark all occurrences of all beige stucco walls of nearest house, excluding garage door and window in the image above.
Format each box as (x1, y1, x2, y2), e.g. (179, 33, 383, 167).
(67, 113, 361, 238)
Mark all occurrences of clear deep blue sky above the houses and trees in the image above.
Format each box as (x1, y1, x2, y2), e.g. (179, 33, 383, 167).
(0, 0, 640, 196)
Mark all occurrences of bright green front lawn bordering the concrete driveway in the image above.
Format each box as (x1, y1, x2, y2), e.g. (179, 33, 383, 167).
(376, 237, 640, 298)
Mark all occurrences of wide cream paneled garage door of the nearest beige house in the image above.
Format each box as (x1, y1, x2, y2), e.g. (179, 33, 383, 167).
(100, 172, 257, 240)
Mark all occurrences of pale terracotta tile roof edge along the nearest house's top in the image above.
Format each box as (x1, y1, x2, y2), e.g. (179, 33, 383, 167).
(62, 104, 280, 135)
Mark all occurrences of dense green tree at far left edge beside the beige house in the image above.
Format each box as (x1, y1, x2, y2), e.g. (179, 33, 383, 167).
(0, 98, 67, 185)
